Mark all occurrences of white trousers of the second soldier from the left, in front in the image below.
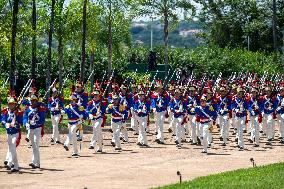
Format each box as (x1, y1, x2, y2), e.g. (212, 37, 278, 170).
(30, 127, 42, 166)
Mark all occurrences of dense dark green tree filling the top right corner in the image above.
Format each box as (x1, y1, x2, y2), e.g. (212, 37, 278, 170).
(195, 0, 284, 52)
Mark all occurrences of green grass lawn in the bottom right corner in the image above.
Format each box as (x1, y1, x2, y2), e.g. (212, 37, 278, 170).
(155, 160, 284, 189)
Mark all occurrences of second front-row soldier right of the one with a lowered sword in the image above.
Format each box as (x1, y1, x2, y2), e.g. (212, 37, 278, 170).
(106, 94, 128, 151)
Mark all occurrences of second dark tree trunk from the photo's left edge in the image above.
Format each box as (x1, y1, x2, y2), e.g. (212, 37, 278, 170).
(31, 0, 37, 79)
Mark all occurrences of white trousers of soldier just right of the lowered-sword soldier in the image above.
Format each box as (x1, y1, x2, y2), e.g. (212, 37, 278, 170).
(90, 118, 103, 150)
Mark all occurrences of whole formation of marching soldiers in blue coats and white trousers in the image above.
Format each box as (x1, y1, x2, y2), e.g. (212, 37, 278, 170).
(1, 81, 284, 172)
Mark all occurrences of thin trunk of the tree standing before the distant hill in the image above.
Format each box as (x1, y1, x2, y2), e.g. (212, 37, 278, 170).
(164, 0, 169, 76)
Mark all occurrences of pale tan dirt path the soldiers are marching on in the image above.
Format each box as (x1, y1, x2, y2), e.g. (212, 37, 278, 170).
(0, 126, 284, 189)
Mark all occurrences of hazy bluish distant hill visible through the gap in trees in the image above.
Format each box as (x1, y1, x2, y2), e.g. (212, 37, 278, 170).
(130, 21, 201, 48)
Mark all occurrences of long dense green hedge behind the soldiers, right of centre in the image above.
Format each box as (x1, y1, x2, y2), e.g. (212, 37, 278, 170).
(127, 46, 284, 77)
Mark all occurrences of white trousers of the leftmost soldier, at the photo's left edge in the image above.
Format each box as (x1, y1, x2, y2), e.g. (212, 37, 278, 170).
(7, 133, 19, 170)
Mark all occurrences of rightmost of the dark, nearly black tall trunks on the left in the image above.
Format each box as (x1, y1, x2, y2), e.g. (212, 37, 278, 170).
(80, 0, 87, 82)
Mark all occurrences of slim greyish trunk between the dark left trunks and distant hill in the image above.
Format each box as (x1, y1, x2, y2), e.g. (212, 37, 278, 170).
(108, 1, 112, 78)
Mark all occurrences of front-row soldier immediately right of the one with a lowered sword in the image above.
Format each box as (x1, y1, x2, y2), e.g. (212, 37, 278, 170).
(87, 89, 107, 152)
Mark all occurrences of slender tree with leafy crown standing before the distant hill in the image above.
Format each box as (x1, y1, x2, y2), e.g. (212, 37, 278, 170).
(140, 0, 195, 74)
